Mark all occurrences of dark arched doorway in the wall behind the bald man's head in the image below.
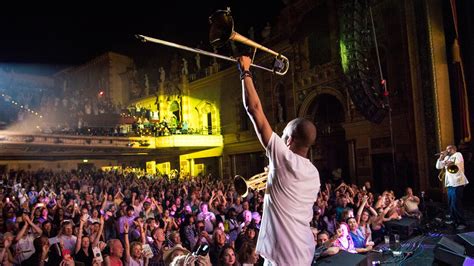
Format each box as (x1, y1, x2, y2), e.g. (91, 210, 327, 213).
(306, 93, 350, 183)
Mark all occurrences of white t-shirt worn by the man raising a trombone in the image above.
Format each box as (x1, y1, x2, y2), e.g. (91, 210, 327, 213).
(257, 133, 320, 265)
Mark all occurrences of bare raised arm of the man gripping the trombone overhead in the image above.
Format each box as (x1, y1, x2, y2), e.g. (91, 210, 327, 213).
(239, 56, 273, 147)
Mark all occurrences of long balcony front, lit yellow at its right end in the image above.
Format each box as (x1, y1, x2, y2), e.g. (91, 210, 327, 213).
(0, 131, 223, 160)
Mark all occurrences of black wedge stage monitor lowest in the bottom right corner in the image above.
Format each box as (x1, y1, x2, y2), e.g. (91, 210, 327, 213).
(434, 236, 467, 265)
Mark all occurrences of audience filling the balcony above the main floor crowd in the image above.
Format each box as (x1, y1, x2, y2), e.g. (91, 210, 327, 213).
(0, 87, 209, 137)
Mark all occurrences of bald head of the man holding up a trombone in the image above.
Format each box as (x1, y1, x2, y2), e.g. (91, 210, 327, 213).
(283, 118, 316, 149)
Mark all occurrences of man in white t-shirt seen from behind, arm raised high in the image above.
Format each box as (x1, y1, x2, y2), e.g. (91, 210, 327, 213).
(239, 56, 320, 265)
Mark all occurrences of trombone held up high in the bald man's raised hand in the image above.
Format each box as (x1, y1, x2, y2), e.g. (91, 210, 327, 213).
(135, 8, 290, 76)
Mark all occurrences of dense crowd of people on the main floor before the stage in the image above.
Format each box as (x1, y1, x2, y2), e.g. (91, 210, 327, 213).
(0, 170, 421, 265)
